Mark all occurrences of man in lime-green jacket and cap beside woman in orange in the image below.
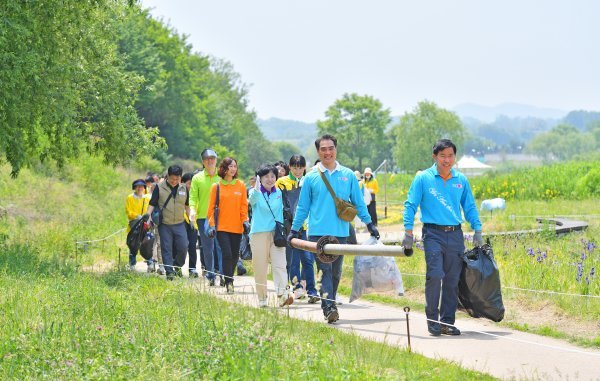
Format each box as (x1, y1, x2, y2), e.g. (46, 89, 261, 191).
(190, 148, 225, 286)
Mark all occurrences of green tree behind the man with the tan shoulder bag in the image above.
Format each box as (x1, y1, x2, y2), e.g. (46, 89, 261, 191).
(317, 93, 391, 171)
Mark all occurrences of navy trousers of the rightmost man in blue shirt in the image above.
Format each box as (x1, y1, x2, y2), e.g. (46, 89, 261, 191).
(423, 226, 465, 324)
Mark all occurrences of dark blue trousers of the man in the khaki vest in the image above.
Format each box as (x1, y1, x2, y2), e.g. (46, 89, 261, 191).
(158, 222, 188, 275)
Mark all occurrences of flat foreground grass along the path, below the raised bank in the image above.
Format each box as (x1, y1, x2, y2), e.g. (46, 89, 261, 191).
(0, 245, 492, 380)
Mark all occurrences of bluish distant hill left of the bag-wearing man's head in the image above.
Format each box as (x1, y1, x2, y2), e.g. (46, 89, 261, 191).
(257, 118, 317, 152)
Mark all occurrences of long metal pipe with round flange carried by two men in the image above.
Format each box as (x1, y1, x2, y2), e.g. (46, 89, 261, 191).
(291, 236, 413, 263)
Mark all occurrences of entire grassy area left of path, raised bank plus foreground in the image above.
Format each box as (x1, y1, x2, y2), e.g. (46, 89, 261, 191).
(0, 157, 491, 380)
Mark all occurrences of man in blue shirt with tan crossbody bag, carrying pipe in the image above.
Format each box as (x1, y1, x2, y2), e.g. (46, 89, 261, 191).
(288, 134, 379, 324)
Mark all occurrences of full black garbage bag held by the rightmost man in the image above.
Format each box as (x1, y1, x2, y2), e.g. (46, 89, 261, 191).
(458, 239, 504, 322)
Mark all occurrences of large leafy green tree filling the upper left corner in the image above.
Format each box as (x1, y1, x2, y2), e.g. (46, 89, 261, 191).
(0, 0, 158, 176)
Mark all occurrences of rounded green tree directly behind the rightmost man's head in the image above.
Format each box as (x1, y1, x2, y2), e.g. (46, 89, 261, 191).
(391, 101, 466, 173)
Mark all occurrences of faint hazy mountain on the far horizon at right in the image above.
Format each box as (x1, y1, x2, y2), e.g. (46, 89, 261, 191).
(452, 103, 568, 123)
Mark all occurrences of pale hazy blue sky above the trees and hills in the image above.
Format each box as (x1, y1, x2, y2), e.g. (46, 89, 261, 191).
(142, 0, 600, 122)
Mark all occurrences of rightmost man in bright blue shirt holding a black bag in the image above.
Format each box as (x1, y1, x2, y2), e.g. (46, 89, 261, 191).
(402, 139, 483, 336)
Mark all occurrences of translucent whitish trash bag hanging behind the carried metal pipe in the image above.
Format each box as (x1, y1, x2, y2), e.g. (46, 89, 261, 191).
(350, 237, 404, 303)
